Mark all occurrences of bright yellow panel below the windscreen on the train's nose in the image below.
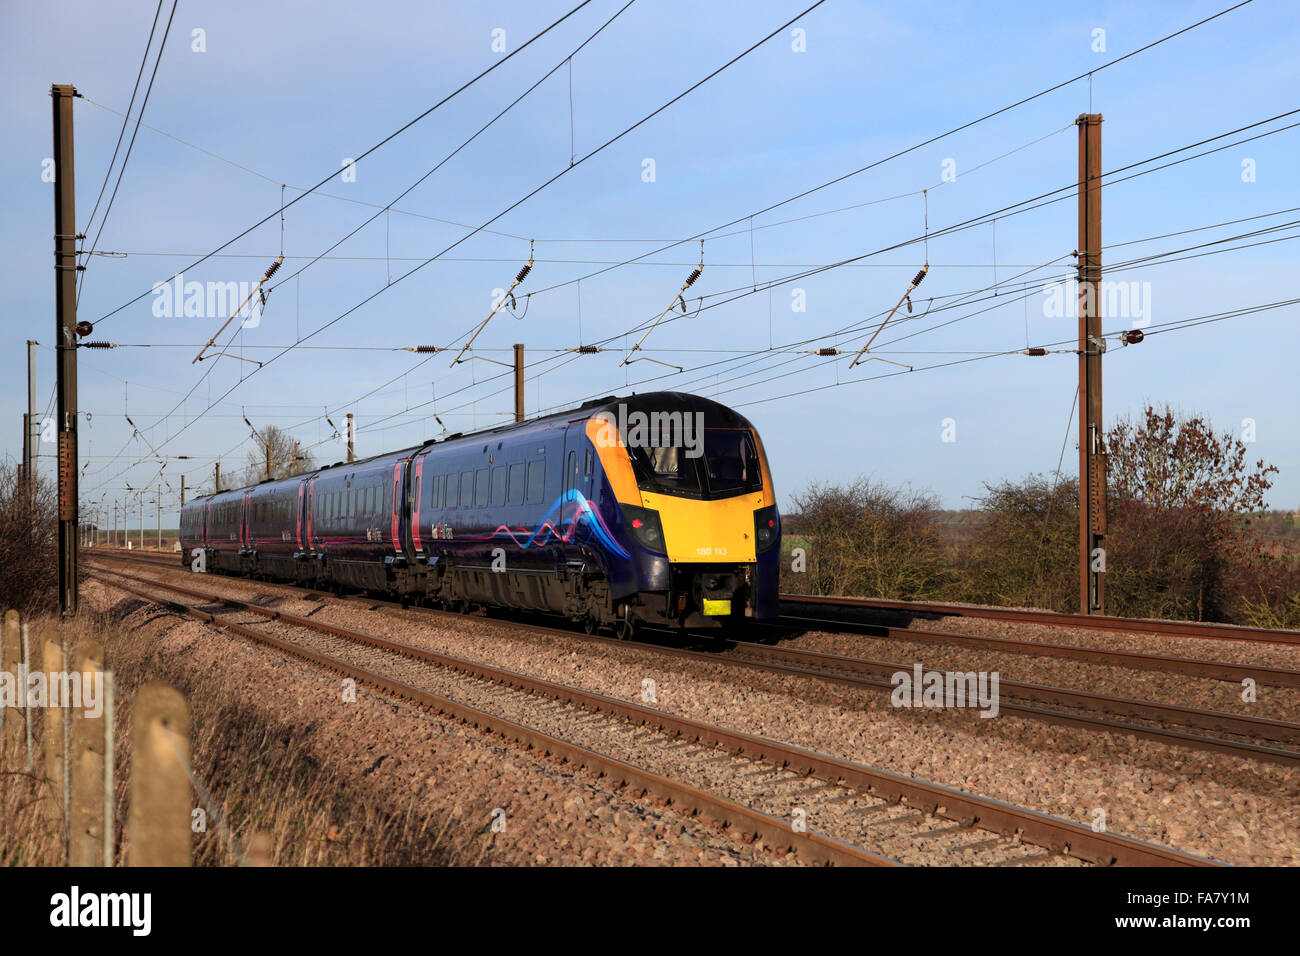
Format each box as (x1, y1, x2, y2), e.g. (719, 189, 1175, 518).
(638, 492, 764, 564)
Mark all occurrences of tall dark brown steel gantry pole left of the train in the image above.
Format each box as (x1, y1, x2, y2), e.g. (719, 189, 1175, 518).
(49, 83, 77, 617)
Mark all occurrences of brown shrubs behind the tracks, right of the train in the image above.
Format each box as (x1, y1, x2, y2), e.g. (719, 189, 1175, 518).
(783, 407, 1300, 627)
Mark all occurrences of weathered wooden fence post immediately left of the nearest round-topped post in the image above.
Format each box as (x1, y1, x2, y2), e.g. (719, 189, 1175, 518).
(62, 640, 105, 866)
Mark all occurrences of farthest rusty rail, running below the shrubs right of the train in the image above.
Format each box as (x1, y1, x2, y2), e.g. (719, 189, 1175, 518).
(780, 594, 1300, 645)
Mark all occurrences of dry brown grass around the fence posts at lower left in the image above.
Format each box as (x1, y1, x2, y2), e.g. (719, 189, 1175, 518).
(0, 609, 484, 866)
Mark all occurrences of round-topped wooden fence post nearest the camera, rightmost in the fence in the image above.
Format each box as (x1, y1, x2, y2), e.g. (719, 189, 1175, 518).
(127, 683, 192, 866)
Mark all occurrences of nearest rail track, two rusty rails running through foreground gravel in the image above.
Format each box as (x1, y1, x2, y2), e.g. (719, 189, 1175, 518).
(92, 567, 1214, 866)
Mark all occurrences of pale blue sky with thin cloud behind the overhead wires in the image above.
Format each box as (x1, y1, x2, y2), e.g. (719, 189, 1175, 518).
(0, 0, 1300, 524)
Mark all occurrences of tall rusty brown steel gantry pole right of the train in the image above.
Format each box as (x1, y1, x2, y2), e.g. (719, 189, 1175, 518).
(1075, 113, 1106, 614)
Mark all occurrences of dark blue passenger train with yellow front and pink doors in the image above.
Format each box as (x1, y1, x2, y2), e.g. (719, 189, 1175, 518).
(181, 392, 781, 637)
